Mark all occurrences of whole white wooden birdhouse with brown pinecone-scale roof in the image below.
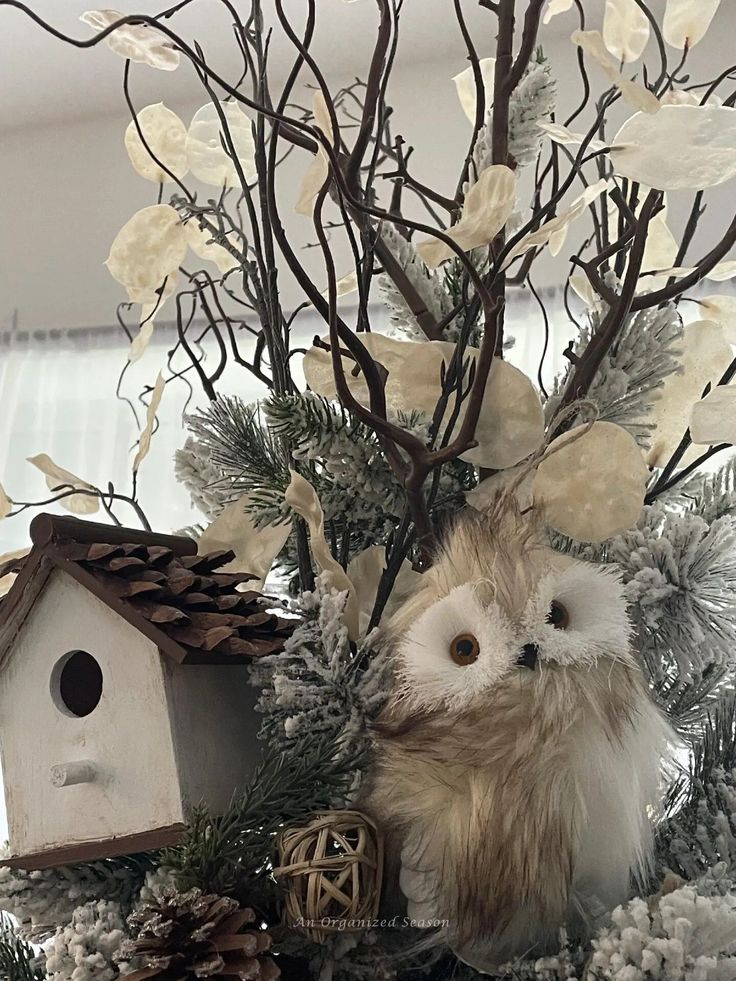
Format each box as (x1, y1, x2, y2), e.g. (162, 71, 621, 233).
(0, 515, 294, 869)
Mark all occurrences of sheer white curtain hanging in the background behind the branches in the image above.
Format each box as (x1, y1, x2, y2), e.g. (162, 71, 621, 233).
(0, 291, 574, 553)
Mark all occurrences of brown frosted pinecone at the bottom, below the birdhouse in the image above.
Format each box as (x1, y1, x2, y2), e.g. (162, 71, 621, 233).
(118, 888, 281, 981)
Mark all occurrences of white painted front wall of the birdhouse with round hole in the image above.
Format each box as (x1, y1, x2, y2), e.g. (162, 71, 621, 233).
(0, 571, 183, 855)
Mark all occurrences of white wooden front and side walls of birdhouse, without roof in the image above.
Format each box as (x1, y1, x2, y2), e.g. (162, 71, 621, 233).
(0, 570, 258, 855)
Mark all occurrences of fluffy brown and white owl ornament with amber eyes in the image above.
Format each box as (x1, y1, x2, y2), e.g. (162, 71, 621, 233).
(361, 496, 675, 972)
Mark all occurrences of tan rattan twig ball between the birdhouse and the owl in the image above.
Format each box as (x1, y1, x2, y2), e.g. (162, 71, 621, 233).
(274, 811, 383, 943)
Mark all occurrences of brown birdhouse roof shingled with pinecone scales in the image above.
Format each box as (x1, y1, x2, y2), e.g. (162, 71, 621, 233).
(0, 514, 297, 664)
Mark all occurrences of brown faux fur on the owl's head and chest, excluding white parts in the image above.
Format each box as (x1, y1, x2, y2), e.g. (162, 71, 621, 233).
(361, 497, 672, 966)
